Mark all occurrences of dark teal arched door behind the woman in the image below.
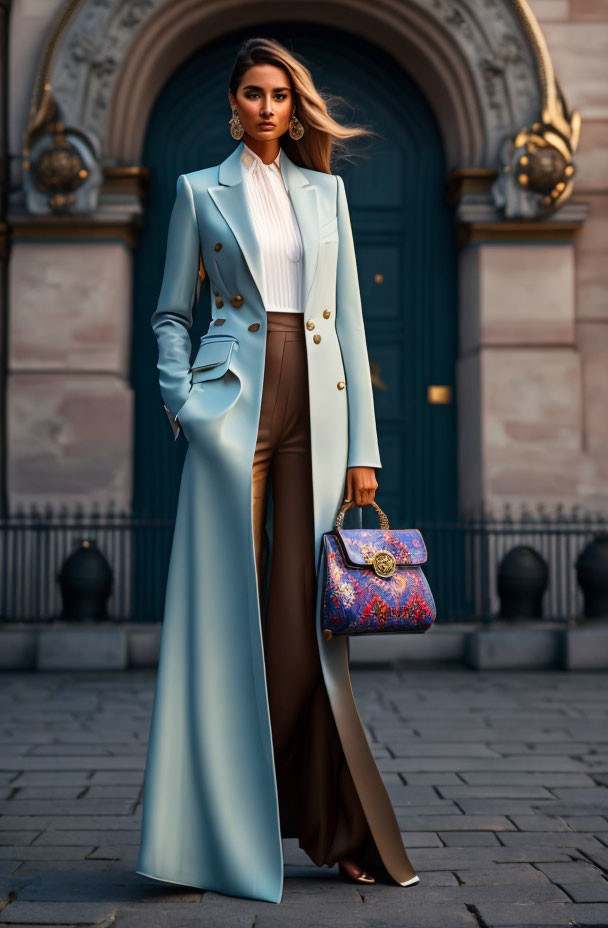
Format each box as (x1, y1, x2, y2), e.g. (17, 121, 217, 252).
(132, 23, 457, 616)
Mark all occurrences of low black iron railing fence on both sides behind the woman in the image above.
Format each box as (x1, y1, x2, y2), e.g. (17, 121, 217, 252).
(0, 506, 608, 623)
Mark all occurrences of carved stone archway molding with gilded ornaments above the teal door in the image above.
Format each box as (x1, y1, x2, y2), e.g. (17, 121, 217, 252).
(23, 0, 581, 219)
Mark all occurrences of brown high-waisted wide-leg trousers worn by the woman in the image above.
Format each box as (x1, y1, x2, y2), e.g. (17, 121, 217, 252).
(252, 312, 373, 866)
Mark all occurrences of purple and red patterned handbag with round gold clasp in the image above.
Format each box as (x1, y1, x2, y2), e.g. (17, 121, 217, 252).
(319, 500, 436, 640)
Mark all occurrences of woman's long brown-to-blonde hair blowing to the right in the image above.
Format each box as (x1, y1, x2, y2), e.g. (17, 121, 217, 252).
(229, 38, 378, 174)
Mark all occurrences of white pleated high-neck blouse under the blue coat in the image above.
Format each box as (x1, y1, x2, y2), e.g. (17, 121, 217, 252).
(241, 143, 304, 313)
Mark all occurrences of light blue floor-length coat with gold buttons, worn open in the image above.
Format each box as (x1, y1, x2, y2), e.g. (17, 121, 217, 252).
(137, 142, 415, 902)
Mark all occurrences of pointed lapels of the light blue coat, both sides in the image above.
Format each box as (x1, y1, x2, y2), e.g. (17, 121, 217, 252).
(208, 141, 320, 313)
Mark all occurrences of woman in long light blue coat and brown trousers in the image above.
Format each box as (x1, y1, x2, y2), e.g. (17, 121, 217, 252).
(137, 39, 418, 902)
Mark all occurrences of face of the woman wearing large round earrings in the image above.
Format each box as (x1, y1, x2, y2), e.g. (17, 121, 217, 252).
(228, 64, 294, 141)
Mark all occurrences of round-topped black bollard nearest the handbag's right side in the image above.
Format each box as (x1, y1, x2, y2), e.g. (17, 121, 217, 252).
(498, 545, 549, 619)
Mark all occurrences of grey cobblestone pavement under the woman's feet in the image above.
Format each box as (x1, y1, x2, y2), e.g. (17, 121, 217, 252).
(0, 665, 608, 928)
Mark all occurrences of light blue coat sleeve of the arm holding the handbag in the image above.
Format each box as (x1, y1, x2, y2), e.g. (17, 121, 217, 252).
(336, 175, 382, 467)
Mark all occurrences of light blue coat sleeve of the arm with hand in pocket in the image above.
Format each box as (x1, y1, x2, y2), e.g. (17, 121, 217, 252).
(151, 174, 200, 438)
